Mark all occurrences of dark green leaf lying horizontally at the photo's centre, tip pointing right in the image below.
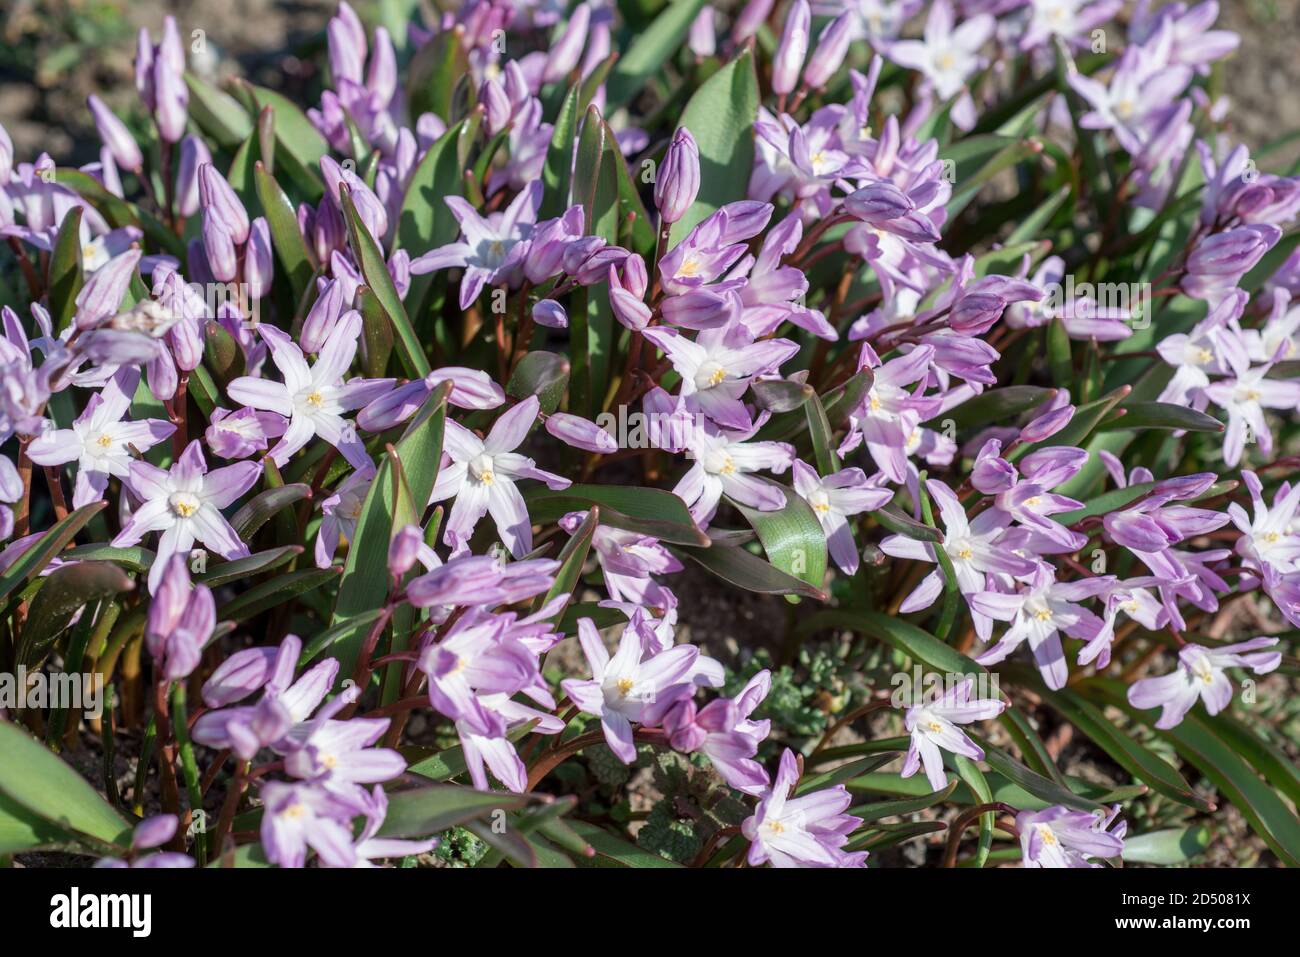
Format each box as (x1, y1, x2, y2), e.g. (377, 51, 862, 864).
(524, 485, 709, 546)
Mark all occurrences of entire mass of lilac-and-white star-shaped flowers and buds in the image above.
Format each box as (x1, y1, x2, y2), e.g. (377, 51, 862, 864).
(0, 0, 1300, 866)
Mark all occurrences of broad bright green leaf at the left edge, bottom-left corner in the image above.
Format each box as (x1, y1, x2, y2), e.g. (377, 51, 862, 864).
(0, 720, 131, 849)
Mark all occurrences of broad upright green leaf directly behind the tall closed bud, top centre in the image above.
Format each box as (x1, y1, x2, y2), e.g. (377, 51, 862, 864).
(670, 47, 759, 246)
